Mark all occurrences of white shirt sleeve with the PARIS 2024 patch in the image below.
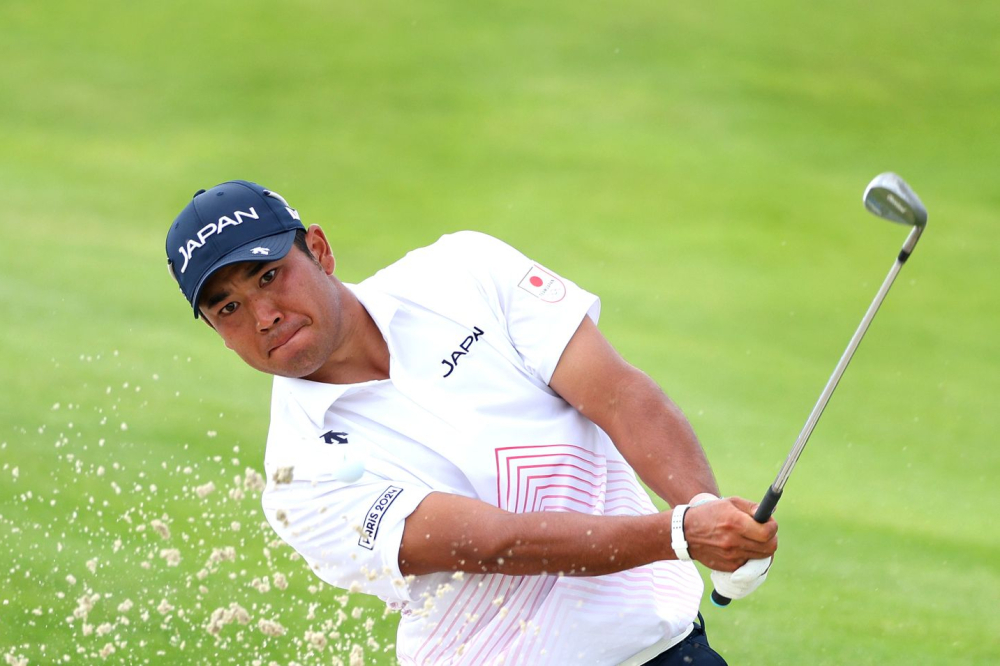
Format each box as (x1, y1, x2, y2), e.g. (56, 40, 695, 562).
(262, 452, 431, 602)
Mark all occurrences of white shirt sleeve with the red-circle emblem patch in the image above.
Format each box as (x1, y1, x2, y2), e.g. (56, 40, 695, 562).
(443, 231, 601, 384)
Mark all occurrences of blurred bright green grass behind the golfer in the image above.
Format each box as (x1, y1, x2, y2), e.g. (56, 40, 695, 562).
(0, 0, 1000, 666)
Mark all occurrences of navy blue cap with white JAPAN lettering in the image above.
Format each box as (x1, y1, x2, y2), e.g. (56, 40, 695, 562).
(167, 180, 305, 318)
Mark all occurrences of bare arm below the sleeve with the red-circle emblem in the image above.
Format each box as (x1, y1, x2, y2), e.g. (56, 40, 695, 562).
(549, 317, 719, 506)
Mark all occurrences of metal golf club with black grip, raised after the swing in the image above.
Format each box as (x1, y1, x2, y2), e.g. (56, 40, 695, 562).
(712, 173, 927, 606)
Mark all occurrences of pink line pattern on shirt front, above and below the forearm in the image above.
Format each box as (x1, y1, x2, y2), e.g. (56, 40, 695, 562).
(406, 444, 699, 666)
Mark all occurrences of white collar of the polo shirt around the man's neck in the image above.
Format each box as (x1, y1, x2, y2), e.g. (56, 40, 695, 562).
(271, 282, 401, 428)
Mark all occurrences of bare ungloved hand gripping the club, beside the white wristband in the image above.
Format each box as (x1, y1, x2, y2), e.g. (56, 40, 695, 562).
(684, 497, 778, 572)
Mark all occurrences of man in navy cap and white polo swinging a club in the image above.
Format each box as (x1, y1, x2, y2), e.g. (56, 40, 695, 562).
(167, 181, 777, 666)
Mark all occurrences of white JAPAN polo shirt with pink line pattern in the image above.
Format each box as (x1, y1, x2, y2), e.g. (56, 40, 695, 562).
(263, 232, 703, 666)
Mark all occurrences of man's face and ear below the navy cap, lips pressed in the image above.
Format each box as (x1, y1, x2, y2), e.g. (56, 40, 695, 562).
(198, 226, 345, 379)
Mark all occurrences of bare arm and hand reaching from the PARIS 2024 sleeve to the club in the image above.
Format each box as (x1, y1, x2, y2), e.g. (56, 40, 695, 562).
(399, 492, 777, 576)
